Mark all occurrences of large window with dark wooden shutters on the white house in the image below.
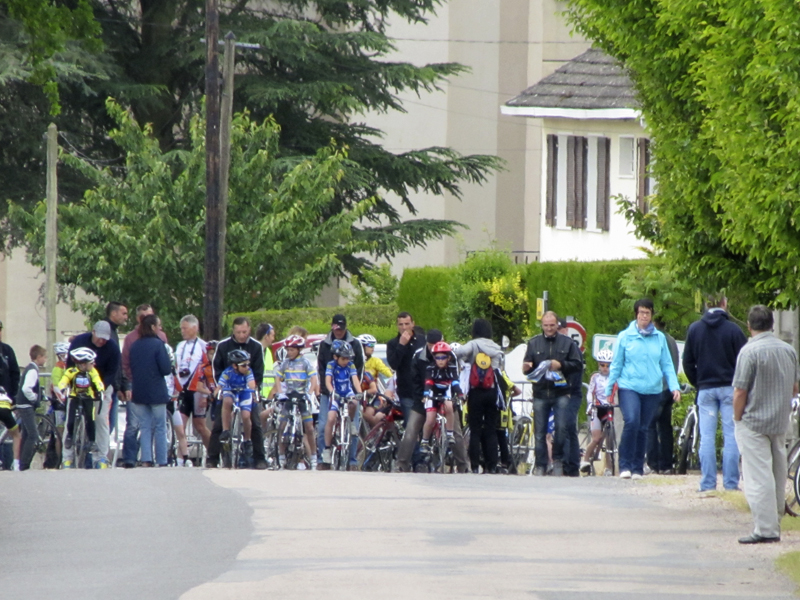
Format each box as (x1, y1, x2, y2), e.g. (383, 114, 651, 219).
(545, 135, 611, 231)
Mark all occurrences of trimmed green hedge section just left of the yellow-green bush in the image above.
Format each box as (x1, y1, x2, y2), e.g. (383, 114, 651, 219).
(397, 267, 455, 329)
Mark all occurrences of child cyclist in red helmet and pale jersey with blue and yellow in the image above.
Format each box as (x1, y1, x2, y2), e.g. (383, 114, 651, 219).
(275, 335, 319, 470)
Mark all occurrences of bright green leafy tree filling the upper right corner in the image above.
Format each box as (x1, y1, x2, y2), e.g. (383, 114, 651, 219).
(568, 0, 800, 307)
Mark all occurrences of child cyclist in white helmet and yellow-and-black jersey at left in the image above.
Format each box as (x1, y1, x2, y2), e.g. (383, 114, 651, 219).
(55, 347, 105, 469)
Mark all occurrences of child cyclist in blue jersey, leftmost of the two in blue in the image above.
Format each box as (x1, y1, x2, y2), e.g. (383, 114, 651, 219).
(219, 349, 256, 466)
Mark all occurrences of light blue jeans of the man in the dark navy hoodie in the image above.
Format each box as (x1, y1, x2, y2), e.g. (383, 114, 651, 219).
(697, 386, 739, 490)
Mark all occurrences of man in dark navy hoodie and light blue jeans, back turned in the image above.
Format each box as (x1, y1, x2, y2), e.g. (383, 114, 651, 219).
(683, 294, 747, 492)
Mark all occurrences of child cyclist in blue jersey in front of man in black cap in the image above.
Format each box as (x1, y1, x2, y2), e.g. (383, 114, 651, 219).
(322, 340, 361, 465)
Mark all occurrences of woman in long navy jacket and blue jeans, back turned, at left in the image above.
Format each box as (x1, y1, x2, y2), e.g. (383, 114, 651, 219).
(130, 315, 172, 467)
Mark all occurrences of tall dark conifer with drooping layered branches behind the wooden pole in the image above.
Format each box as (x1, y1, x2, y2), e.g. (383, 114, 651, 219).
(0, 0, 499, 273)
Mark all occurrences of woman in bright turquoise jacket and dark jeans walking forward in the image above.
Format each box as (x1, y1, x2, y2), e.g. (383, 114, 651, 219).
(606, 298, 681, 479)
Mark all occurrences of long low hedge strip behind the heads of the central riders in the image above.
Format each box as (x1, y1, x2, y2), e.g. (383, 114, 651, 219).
(225, 304, 398, 342)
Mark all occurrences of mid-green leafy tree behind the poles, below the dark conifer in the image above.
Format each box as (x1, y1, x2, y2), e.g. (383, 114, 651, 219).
(10, 101, 375, 322)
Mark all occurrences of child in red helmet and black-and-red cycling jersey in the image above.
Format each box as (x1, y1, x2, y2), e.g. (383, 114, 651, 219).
(420, 341, 462, 453)
